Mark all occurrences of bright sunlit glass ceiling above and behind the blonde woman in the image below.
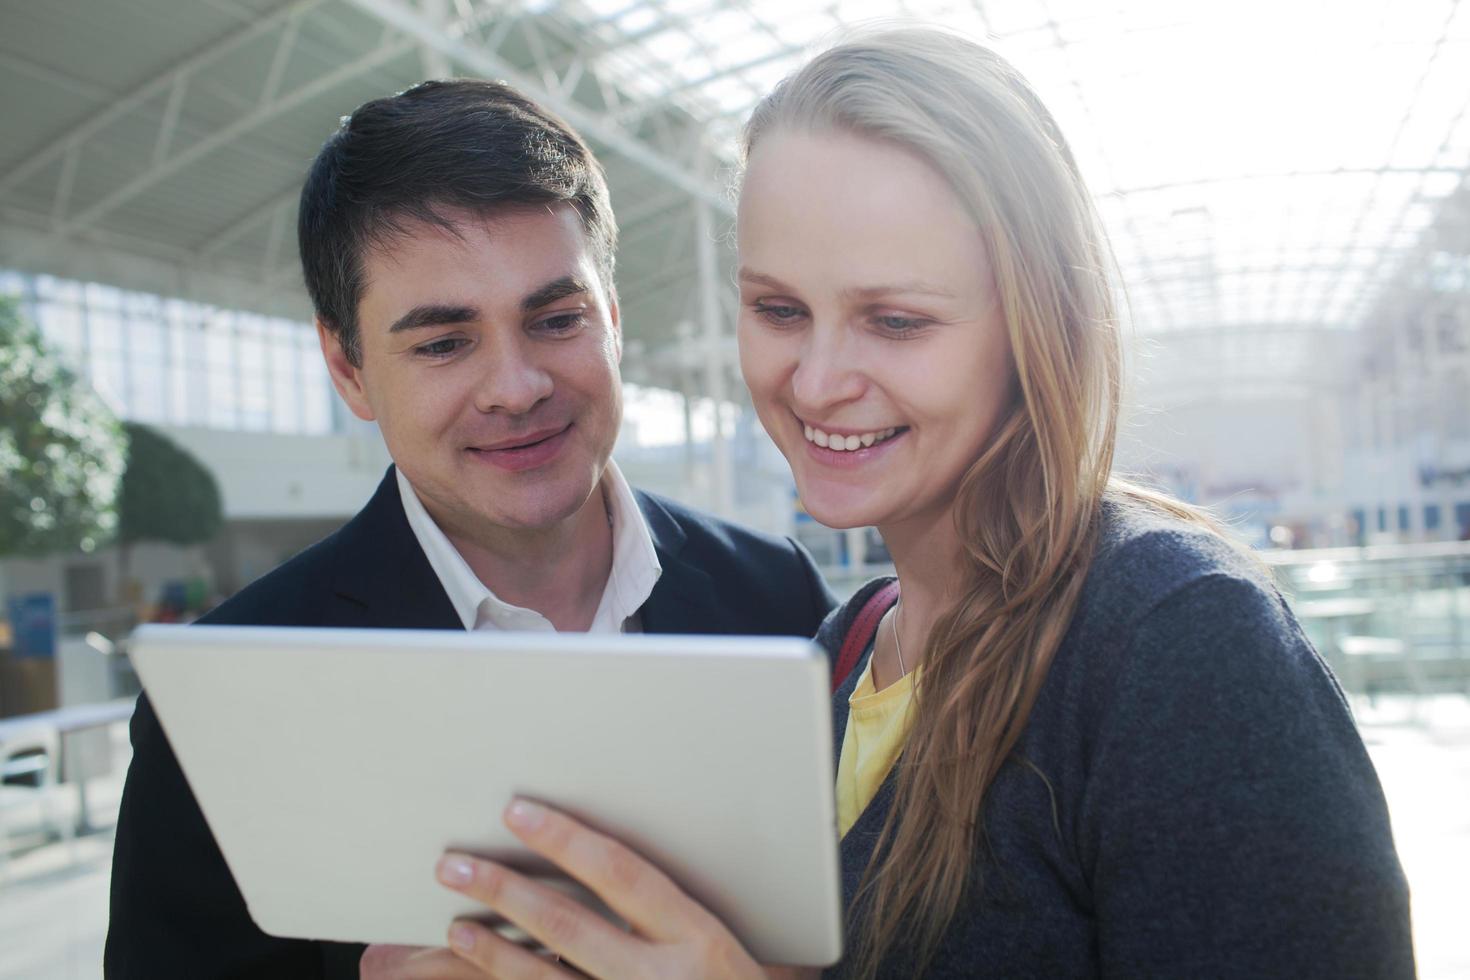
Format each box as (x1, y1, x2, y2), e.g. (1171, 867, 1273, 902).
(540, 0, 1470, 339)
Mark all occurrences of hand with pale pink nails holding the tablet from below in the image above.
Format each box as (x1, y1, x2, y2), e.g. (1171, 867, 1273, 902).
(438, 799, 816, 980)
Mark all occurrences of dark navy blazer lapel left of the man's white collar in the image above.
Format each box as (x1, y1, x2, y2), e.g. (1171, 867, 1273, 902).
(326, 466, 465, 629)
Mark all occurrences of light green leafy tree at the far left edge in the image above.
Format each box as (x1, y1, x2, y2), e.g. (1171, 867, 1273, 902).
(0, 297, 126, 557)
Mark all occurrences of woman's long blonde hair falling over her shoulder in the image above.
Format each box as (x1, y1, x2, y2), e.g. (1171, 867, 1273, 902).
(744, 28, 1195, 977)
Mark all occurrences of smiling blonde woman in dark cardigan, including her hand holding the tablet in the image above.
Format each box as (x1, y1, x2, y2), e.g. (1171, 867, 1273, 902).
(414, 31, 1413, 977)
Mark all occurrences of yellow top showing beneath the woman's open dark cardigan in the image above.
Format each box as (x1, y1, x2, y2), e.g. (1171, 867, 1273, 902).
(836, 657, 917, 836)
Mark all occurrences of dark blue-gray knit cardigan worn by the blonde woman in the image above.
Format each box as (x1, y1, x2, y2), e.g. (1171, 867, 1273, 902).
(817, 500, 1414, 979)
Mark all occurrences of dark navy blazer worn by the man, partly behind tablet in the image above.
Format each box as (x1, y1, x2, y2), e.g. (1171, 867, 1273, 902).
(103, 467, 835, 980)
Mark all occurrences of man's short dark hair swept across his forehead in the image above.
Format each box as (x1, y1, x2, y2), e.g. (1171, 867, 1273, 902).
(297, 79, 617, 364)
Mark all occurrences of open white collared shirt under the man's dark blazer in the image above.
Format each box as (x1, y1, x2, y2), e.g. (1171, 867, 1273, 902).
(394, 460, 663, 633)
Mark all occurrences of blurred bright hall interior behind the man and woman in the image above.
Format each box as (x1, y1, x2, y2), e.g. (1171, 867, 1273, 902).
(0, 0, 1470, 980)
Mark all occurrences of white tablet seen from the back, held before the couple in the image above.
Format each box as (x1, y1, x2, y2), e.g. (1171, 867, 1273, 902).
(129, 626, 841, 965)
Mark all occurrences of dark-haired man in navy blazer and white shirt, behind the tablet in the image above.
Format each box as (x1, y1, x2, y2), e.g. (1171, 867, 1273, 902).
(104, 81, 833, 980)
